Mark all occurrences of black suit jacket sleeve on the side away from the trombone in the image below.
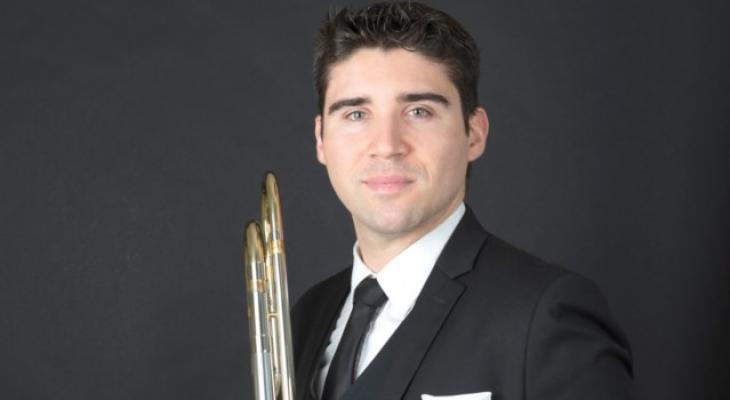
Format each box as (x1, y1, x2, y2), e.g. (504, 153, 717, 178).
(525, 274, 634, 400)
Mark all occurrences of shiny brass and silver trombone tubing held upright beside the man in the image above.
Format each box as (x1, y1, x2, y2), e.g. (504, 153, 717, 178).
(243, 172, 294, 400)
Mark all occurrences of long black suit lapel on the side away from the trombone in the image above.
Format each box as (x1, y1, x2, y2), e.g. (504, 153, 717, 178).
(344, 208, 487, 400)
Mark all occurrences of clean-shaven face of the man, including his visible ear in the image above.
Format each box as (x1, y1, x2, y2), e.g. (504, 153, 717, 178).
(315, 48, 488, 245)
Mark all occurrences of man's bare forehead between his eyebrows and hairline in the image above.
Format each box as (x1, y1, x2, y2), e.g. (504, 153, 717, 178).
(325, 48, 459, 104)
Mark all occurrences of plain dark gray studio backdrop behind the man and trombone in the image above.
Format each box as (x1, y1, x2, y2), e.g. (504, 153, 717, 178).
(0, 0, 730, 399)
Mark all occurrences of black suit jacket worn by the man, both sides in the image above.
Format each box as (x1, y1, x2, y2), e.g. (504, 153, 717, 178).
(292, 208, 633, 400)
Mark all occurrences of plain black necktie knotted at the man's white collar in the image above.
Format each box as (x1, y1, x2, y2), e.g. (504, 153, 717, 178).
(322, 277, 388, 400)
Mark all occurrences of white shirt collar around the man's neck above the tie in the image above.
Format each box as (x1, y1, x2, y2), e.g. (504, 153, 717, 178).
(350, 203, 466, 320)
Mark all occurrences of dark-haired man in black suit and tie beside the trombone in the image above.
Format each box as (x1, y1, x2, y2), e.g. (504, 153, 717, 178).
(292, 3, 632, 400)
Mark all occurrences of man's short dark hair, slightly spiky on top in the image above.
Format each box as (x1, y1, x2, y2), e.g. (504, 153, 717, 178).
(314, 2, 479, 124)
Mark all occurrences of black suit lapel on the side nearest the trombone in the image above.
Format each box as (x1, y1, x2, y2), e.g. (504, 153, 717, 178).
(296, 268, 352, 400)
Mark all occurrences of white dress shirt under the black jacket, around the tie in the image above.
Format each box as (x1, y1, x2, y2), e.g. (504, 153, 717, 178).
(315, 203, 466, 398)
